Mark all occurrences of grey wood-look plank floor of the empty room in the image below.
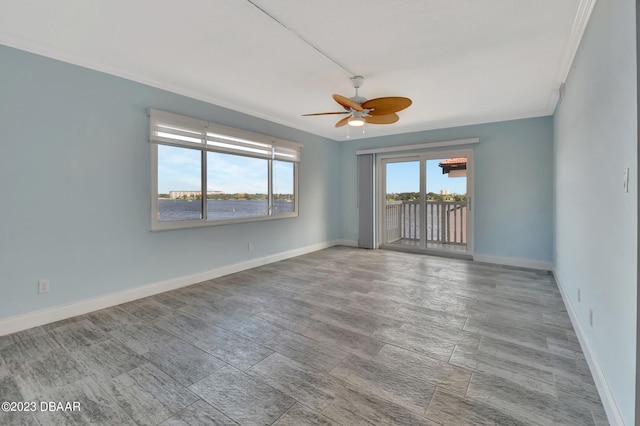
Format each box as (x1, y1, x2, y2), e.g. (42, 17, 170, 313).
(0, 247, 608, 426)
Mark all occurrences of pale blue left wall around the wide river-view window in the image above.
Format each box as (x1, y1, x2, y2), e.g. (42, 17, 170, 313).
(0, 46, 340, 319)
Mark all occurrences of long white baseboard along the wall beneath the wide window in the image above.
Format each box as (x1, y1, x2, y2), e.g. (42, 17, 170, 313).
(0, 240, 345, 336)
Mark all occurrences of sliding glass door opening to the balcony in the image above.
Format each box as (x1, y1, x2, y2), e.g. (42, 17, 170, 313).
(378, 151, 473, 255)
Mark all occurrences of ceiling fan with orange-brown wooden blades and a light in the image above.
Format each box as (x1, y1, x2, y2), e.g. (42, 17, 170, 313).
(303, 75, 411, 127)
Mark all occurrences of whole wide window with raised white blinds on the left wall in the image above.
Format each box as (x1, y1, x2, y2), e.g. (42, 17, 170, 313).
(150, 110, 301, 230)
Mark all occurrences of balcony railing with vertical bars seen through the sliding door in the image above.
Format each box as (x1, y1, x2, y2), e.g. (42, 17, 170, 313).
(386, 201, 467, 245)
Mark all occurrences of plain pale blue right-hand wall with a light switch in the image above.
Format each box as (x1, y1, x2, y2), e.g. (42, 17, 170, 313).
(554, 0, 638, 425)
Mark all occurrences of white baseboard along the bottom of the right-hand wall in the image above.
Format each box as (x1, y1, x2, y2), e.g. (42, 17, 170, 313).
(553, 270, 624, 426)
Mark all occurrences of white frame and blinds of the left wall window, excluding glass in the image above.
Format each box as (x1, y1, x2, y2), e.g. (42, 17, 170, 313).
(149, 109, 302, 231)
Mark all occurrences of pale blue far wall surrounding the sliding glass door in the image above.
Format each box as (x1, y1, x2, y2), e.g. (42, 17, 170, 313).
(340, 117, 553, 262)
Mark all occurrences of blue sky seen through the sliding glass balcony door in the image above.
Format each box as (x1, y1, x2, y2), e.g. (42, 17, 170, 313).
(387, 159, 467, 194)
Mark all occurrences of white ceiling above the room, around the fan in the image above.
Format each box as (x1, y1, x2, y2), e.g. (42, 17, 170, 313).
(0, 0, 595, 140)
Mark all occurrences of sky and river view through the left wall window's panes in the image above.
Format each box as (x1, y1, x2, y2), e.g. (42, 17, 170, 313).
(158, 145, 295, 222)
